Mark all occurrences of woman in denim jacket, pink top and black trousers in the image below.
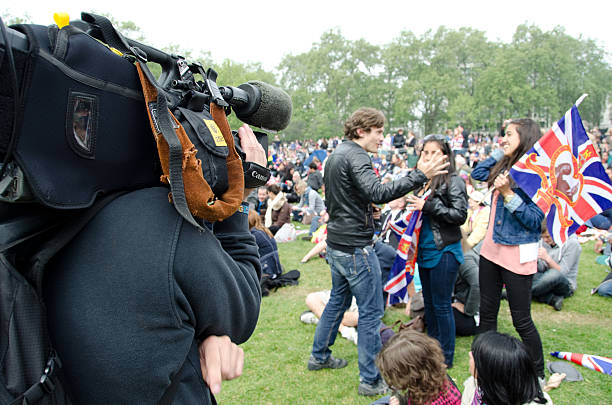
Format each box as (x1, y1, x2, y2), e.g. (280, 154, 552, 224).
(472, 118, 544, 378)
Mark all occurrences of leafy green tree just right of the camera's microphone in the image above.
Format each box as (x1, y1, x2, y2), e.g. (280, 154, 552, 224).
(279, 30, 381, 139)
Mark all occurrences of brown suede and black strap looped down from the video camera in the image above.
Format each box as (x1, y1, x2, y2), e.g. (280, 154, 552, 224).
(82, 13, 244, 224)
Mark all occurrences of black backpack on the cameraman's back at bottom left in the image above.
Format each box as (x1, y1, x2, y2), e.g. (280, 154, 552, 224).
(0, 195, 118, 405)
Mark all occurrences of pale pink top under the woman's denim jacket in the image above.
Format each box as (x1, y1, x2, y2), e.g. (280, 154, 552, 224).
(480, 191, 538, 276)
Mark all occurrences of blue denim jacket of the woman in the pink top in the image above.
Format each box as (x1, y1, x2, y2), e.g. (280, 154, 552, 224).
(472, 150, 544, 245)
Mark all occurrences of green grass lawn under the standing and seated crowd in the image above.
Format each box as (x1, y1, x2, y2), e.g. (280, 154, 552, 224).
(217, 226, 612, 404)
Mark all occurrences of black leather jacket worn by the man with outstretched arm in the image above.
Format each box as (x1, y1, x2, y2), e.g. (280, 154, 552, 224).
(323, 140, 427, 253)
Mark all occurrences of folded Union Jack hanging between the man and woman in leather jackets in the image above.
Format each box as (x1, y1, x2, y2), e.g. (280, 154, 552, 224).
(383, 190, 429, 305)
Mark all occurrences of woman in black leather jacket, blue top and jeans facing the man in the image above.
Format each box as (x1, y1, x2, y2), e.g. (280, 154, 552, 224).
(407, 135, 468, 368)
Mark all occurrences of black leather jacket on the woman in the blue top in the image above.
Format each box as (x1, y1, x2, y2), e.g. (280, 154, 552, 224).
(423, 173, 468, 250)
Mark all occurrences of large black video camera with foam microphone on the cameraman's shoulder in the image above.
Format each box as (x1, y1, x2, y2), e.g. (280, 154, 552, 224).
(0, 13, 292, 215)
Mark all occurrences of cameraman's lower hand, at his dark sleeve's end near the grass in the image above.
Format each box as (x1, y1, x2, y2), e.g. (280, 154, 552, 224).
(200, 334, 241, 395)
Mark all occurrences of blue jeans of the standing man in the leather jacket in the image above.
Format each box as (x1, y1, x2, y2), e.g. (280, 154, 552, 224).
(312, 246, 384, 384)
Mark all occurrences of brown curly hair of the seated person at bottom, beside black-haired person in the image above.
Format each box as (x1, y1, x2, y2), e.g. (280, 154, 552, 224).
(376, 329, 446, 405)
